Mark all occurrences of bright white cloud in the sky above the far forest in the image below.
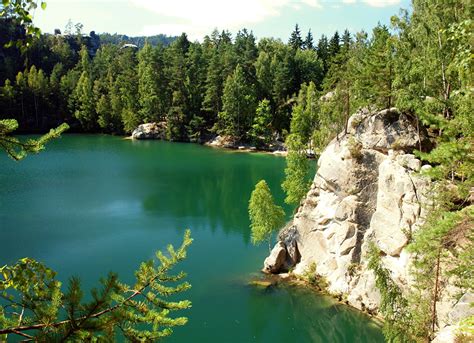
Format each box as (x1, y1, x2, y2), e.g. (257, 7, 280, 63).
(131, 0, 321, 39)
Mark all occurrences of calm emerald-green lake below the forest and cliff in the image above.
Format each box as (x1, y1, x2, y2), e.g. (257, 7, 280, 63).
(0, 135, 383, 343)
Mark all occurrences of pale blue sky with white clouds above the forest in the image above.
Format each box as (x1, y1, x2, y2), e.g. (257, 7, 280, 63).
(34, 0, 410, 41)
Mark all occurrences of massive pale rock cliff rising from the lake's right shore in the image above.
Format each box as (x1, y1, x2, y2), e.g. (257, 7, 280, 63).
(266, 108, 470, 342)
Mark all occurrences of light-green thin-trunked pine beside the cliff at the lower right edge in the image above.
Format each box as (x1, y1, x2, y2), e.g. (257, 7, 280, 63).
(408, 205, 474, 337)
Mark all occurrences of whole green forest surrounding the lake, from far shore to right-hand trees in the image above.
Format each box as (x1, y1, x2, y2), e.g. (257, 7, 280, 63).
(0, 0, 474, 342)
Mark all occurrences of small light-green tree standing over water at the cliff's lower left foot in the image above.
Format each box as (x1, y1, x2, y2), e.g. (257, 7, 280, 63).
(249, 180, 285, 250)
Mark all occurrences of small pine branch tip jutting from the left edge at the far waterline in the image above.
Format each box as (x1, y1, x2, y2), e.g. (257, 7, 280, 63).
(0, 119, 69, 161)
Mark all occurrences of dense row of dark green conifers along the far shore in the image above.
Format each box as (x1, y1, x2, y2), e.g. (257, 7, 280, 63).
(0, 18, 353, 140)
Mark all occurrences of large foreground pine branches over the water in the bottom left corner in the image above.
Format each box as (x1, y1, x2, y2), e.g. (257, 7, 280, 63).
(0, 230, 192, 342)
